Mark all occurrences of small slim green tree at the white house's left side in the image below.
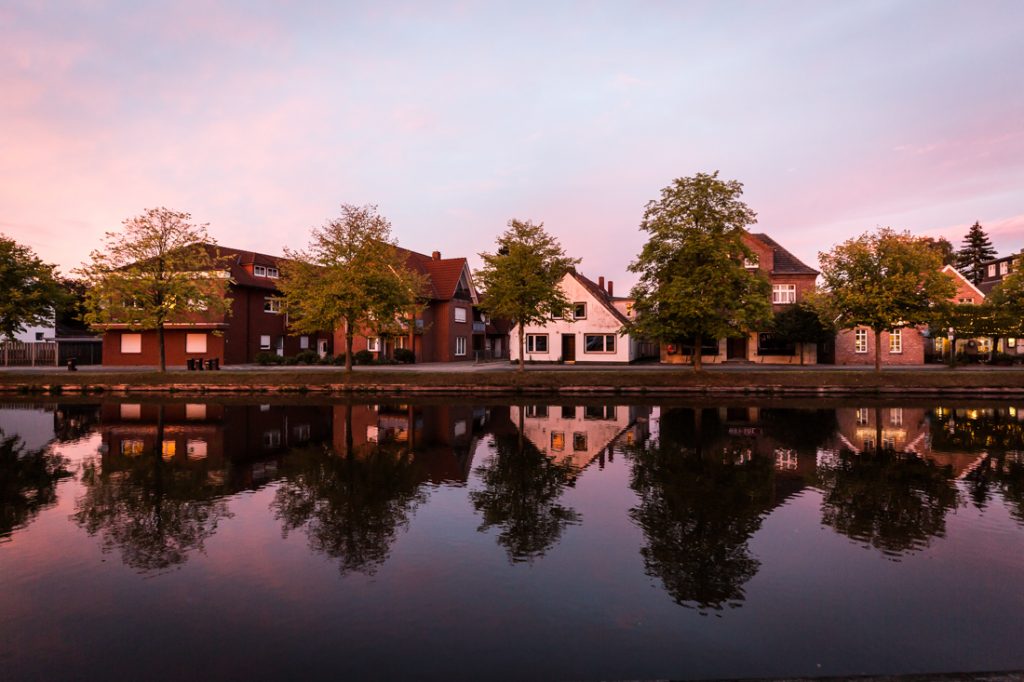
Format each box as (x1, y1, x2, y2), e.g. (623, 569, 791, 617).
(475, 218, 580, 372)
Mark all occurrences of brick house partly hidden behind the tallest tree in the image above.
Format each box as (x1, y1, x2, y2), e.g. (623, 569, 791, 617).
(660, 232, 818, 365)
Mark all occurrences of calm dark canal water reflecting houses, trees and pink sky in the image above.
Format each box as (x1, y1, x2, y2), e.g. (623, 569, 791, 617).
(0, 398, 1024, 680)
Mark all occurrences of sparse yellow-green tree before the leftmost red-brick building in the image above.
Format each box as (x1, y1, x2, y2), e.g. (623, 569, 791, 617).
(78, 207, 230, 372)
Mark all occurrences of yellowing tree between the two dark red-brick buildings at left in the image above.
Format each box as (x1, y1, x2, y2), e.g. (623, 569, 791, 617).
(279, 204, 427, 372)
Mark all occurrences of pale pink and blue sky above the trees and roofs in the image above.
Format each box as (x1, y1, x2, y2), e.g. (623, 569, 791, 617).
(0, 1, 1024, 291)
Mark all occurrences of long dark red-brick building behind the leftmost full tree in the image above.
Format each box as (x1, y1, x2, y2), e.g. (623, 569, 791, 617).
(103, 246, 333, 366)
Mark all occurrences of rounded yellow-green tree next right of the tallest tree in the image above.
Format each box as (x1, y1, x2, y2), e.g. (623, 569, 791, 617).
(818, 227, 955, 372)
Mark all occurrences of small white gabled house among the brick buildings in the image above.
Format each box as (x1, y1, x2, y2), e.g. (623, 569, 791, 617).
(509, 270, 656, 363)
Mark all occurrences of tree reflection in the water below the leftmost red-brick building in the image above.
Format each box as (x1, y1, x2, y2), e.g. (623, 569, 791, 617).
(73, 407, 231, 571)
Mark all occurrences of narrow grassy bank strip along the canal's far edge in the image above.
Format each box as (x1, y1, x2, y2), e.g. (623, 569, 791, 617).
(0, 368, 1024, 396)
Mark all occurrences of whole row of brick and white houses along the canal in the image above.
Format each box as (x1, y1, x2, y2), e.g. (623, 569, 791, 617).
(94, 232, 1024, 366)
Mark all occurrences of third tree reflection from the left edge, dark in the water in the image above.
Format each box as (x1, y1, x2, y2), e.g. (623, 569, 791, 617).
(271, 407, 426, 574)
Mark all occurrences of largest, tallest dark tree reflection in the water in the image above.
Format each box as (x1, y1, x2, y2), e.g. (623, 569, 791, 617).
(630, 410, 774, 609)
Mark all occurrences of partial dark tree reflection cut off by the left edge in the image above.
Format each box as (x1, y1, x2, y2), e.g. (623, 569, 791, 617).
(0, 433, 72, 543)
